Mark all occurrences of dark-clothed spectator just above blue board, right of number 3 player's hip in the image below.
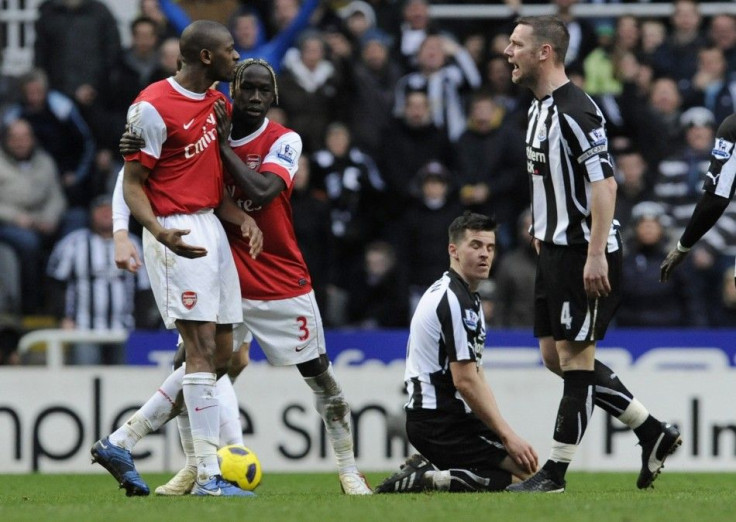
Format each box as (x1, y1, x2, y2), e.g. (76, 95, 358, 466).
(349, 241, 409, 329)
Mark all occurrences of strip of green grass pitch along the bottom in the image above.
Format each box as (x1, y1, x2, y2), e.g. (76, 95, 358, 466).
(0, 472, 736, 522)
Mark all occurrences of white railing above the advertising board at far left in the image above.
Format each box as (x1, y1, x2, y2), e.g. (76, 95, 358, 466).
(18, 329, 129, 368)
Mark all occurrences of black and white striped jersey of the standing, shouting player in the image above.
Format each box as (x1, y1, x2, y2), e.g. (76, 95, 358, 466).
(526, 82, 618, 252)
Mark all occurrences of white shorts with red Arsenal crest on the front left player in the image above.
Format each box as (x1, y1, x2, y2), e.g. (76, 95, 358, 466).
(143, 210, 243, 328)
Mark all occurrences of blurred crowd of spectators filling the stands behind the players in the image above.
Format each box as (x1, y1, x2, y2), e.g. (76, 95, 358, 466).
(0, 0, 736, 363)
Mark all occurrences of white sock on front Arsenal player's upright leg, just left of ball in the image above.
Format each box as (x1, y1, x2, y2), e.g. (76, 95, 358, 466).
(183, 372, 220, 482)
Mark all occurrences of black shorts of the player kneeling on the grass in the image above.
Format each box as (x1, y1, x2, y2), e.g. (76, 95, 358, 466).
(406, 410, 508, 476)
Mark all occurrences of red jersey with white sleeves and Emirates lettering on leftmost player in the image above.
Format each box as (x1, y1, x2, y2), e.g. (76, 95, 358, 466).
(125, 78, 225, 216)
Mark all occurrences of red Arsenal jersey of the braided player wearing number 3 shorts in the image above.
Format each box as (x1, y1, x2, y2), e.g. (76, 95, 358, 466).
(220, 119, 312, 301)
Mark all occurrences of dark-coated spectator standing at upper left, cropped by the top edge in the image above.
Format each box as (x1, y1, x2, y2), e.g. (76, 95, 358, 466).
(34, 0, 120, 152)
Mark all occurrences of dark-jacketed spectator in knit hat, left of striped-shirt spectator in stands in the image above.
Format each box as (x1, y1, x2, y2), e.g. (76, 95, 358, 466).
(349, 29, 401, 157)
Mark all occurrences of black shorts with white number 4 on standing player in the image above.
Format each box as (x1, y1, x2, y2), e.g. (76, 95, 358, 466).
(534, 241, 622, 341)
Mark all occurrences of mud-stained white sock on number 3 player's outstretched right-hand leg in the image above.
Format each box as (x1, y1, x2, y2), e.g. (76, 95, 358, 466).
(304, 364, 358, 473)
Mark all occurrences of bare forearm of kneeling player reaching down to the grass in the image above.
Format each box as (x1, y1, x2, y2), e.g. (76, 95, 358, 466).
(450, 361, 539, 473)
